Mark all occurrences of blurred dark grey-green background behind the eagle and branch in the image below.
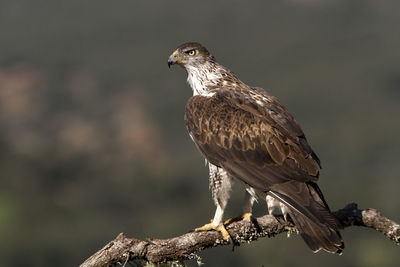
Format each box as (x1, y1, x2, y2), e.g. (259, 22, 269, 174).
(0, 0, 400, 266)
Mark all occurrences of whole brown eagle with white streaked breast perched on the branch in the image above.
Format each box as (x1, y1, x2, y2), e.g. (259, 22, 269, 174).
(168, 42, 344, 254)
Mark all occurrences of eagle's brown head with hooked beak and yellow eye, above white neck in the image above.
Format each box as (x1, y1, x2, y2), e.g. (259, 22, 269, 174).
(168, 43, 214, 69)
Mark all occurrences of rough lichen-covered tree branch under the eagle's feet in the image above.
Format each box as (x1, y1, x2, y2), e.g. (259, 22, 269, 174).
(80, 203, 400, 267)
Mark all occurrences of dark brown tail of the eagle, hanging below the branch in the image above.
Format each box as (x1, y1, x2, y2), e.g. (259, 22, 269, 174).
(269, 180, 344, 254)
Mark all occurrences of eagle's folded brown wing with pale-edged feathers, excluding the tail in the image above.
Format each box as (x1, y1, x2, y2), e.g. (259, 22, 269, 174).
(185, 89, 319, 191)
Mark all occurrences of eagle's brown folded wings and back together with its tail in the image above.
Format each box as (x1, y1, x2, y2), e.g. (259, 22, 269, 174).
(185, 88, 344, 253)
